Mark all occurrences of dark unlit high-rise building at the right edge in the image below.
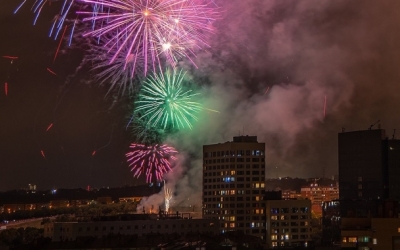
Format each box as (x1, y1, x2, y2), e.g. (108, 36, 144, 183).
(338, 129, 400, 200)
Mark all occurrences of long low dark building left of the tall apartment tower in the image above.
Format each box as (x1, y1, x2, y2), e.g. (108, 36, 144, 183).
(44, 214, 219, 241)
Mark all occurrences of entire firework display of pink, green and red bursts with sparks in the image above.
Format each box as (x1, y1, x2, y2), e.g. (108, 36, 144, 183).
(11, 0, 216, 186)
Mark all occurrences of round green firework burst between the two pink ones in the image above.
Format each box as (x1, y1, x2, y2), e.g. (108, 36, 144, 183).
(134, 70, 202, 130)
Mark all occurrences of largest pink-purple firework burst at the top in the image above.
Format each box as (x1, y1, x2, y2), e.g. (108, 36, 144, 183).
(79, 0, 216, 74)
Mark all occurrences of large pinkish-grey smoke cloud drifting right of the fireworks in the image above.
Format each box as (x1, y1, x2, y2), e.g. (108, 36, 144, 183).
(141, 0, 400, 209)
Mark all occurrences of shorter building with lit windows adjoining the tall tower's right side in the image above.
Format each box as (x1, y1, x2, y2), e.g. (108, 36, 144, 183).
(265, 200, 312, 248)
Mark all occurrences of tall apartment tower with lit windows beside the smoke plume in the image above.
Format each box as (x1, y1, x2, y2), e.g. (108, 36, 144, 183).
(202, 136, 266, 238)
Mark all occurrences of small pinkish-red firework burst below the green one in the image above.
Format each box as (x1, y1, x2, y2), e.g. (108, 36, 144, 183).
(126, 143, 178, 183)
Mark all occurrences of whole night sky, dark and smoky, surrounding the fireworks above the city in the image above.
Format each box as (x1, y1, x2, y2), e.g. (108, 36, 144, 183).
(0, 0, 400, 205)
